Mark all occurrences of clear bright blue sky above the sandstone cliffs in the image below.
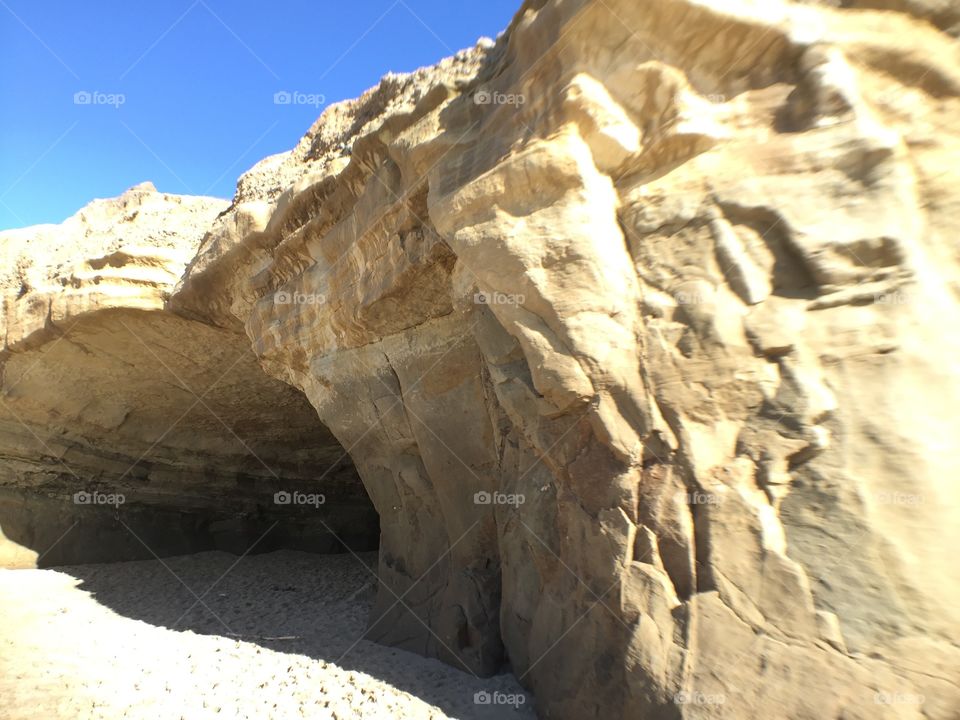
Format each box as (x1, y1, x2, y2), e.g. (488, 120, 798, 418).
(0, 0, 520, 229)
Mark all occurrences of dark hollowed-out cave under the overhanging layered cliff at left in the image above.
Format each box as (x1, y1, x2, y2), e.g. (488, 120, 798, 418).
(0, 309, 379, 567)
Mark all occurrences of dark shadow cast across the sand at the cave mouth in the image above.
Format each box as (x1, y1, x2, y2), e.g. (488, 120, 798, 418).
(47, 550, 535, 718)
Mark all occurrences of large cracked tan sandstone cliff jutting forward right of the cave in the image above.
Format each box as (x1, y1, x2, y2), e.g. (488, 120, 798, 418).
(6, 0, 960, 718)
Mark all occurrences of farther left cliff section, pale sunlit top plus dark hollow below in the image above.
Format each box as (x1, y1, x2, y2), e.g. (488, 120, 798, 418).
(0, 183, 378, 566)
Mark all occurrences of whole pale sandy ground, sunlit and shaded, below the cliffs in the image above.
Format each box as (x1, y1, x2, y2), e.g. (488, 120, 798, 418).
(0, 551, 534, 720)
